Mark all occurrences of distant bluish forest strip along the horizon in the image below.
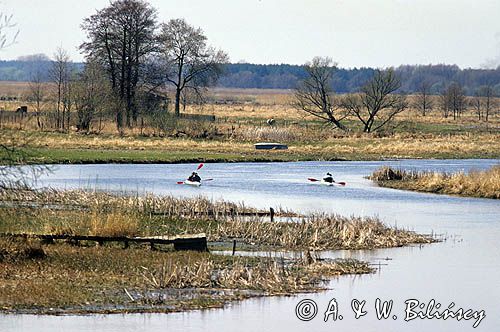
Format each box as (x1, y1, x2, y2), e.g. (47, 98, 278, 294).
(0, 59, 500, 96)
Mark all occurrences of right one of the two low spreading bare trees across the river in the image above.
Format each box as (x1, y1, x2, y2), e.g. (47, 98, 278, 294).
(343, 69, 408, 133)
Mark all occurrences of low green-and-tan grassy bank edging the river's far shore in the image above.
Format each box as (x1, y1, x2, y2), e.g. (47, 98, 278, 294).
(0, 129, 500, 164)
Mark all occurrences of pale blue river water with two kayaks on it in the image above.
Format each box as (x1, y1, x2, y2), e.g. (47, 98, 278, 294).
(0, 160, 500, 332)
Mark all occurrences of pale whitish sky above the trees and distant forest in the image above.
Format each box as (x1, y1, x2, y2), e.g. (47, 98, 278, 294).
(0, 0, 500, 68)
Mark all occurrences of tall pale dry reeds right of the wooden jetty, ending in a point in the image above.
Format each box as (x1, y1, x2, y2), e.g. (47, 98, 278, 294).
(213, 214, 434, 250)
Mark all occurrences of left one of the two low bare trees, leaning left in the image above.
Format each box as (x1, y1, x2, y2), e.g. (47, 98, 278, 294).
(295, 57, 347, 130)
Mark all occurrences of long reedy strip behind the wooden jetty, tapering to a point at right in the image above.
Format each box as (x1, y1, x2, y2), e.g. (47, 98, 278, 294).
(0, 189, 434, 250)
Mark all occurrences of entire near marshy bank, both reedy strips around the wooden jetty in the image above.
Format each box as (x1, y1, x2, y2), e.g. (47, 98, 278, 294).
(0, 190, 435, 314)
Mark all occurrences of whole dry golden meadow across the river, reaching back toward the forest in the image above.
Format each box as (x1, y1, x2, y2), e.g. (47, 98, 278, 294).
(0, 83, 500, 163)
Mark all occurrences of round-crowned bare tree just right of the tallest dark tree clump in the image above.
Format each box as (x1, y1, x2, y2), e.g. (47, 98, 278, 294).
(159, 19, 228, 116)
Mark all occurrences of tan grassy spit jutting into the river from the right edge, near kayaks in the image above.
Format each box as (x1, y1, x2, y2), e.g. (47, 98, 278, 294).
(370, 165, 500, 199)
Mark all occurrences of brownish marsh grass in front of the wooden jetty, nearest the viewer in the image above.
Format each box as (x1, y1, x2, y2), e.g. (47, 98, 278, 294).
(0, 239, 372, 314)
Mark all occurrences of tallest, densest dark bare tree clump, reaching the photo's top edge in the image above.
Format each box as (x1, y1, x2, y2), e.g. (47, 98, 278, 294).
(80, 0, 157, 130)
